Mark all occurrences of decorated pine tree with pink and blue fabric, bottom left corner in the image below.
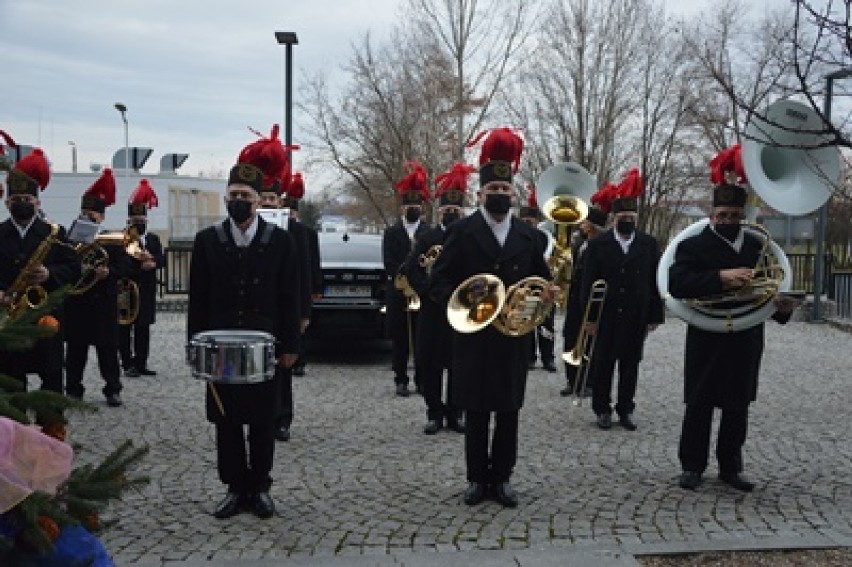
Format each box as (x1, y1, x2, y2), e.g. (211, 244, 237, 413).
(0, 290, 148, 567)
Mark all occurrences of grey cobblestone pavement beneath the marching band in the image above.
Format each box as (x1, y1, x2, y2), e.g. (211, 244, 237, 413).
(61, 313, 852, 566)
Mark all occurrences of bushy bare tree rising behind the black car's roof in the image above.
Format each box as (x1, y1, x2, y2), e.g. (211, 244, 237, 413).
(300, 30, 460, 224)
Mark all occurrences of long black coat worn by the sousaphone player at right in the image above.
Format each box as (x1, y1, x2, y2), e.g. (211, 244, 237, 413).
(669, 227, 790, 408)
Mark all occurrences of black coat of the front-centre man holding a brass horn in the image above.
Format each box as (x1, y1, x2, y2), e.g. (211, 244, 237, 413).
(429, 211, 550, 412)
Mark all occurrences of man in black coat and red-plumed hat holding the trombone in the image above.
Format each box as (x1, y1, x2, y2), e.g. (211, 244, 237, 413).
(580, 169, 665, 431)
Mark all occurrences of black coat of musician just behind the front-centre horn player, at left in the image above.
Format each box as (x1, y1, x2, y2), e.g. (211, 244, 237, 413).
(402, 225, 453, 368)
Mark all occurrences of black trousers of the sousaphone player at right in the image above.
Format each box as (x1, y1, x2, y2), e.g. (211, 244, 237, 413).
(678, 404, 748, 474)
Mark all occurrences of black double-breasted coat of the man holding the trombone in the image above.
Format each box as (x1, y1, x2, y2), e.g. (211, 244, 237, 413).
(580, 229, 665, 361)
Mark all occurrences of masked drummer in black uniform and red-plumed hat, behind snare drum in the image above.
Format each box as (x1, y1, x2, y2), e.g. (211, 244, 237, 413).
(187, 131, 300, 518)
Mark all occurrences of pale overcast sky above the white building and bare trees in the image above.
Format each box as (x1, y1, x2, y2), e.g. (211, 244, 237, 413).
(0, 0, 789, 192)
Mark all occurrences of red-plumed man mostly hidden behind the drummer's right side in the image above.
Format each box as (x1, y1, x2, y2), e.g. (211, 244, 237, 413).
(260, 169, 311, 441)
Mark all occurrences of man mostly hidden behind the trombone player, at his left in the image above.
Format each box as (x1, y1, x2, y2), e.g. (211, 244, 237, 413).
(559, 206, 607, 396)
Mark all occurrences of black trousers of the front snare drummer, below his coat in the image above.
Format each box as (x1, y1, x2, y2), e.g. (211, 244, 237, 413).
(216, 420, 275, 494)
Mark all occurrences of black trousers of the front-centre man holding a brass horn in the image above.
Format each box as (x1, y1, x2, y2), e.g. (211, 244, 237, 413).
(464, 410, 519, 484)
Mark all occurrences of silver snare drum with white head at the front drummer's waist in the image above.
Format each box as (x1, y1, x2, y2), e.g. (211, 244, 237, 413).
(186, 329, 276, 384)
